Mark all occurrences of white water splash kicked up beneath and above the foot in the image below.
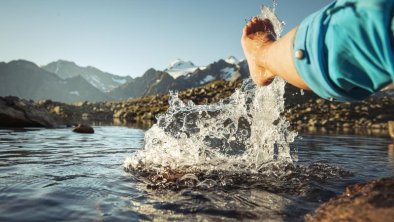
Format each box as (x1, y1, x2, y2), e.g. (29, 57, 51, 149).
(124, 6, 296, 172)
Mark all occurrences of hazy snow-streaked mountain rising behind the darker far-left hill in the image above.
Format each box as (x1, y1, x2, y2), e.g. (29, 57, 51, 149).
(42, 60, 132, 92)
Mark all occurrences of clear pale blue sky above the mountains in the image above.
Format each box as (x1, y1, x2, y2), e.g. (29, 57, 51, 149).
(0, 0, 331, 77)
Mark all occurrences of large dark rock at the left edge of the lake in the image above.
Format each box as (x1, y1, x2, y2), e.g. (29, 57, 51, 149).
(0, 96, 61, 127)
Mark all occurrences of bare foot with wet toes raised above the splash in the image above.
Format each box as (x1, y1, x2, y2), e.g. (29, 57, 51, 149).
(241, 17, 276, 86)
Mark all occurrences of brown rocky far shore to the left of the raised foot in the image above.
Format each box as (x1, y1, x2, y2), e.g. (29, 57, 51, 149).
(33, 81, 241, 125)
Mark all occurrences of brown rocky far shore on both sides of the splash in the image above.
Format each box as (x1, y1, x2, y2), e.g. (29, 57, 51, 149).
(26, 81, 394, 133)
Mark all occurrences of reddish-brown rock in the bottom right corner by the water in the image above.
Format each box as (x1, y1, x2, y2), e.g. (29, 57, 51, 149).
(305, 177, 394, 222)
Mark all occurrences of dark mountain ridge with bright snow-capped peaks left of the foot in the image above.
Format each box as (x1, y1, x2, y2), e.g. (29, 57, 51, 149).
(109, 57, 249, 99)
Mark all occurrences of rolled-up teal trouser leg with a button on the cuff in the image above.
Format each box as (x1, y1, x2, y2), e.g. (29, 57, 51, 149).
(294, 0, 394, 101)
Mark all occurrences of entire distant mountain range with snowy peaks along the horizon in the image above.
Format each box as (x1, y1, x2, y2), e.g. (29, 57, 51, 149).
(0, 57, 249, 103)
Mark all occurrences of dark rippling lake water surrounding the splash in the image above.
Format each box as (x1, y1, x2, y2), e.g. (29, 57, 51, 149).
(0, 126, 394, 221)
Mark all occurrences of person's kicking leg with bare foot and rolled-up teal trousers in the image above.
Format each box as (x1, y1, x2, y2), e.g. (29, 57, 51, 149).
(242, 0, 394, 101)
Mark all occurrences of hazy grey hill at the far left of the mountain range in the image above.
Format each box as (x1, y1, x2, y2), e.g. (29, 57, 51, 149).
(0, 60, 110, 102)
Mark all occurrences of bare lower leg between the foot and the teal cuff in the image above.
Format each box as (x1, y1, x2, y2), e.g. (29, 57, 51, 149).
(257, 28, 309, 89)
